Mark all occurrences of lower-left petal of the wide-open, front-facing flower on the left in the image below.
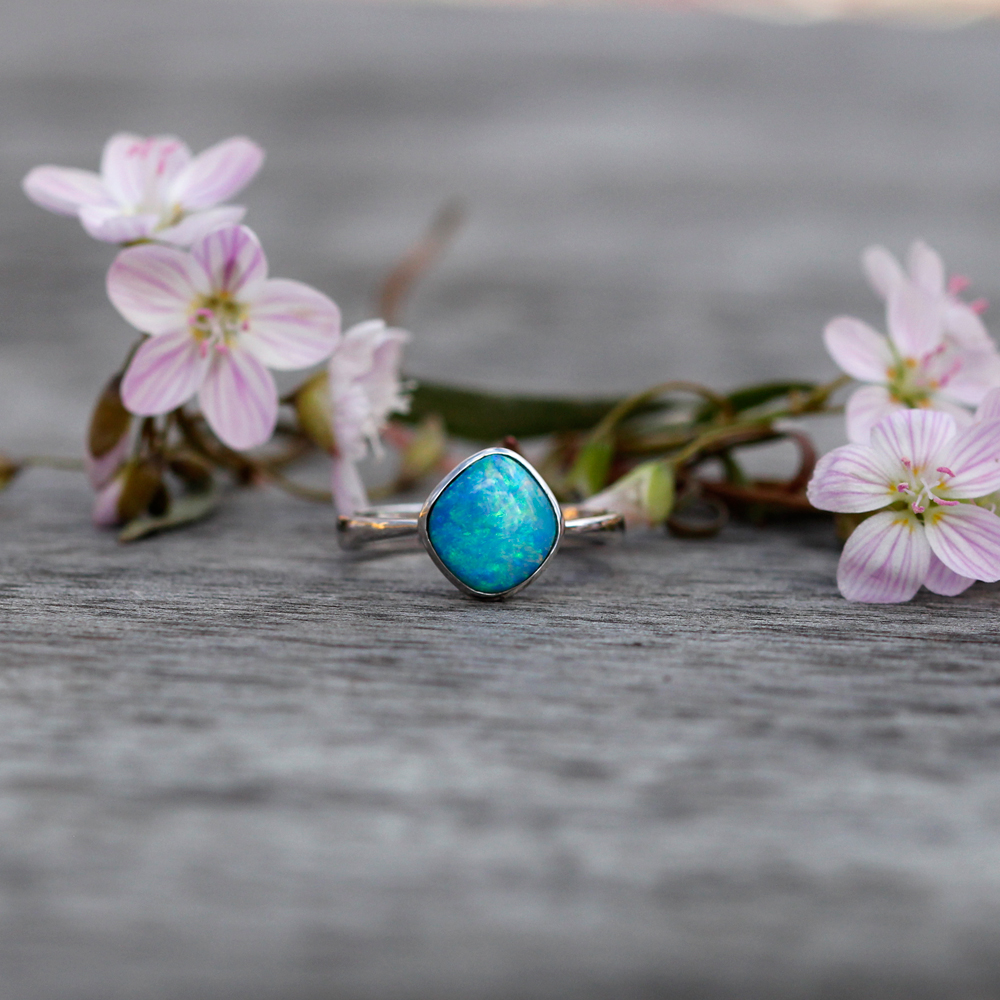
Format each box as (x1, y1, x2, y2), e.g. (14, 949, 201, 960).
(122, 329, 208, 416)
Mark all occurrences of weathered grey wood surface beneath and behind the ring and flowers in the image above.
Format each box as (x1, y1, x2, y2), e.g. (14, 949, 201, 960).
(0, 0, 1000, 1000)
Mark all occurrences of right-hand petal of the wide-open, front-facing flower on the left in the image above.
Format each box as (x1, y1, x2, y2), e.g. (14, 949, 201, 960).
(240, 278, 340, 370)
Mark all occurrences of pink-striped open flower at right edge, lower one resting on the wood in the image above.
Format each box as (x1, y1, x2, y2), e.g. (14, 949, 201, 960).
(808, 410, 1000, 604)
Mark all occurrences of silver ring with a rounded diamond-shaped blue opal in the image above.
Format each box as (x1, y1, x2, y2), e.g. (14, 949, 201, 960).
(337, 448, 625, 601)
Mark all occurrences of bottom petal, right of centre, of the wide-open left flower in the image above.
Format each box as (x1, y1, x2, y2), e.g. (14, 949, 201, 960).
(198, 348, 278, 450)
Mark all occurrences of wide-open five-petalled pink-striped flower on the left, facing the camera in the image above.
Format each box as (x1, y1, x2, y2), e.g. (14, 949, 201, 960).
(108, 226, 340, 448)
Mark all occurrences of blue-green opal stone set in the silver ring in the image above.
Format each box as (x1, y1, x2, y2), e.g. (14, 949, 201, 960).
(427, 454, 559, 594)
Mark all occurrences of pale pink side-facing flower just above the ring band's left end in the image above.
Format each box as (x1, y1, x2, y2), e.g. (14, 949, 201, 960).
(329, 319, 410, 514)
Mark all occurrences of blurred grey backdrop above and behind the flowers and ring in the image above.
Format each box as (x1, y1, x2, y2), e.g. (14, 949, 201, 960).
(0, 0, 1000, 460)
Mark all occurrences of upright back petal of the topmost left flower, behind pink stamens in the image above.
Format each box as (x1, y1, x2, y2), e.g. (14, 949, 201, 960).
(101, 132, 191, 210)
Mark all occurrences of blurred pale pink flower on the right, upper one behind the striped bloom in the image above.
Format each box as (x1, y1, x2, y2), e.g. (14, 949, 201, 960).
(823, 243, 1000, 444)
